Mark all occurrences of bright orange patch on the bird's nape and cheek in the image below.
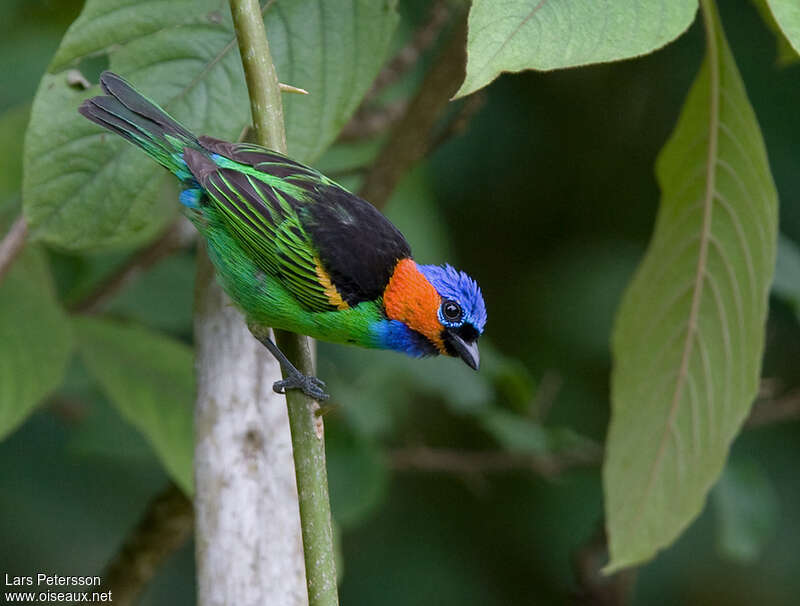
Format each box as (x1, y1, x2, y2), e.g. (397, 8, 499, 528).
(383, 259, 446, 354)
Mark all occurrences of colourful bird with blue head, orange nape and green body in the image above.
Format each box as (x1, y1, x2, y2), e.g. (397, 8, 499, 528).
(78, 71, 487, 400)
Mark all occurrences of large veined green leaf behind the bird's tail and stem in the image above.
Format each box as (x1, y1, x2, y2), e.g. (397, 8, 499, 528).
(23, 0, 397, 249)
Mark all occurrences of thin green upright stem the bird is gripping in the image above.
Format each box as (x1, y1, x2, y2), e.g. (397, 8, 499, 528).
(230, 0, 338, 606)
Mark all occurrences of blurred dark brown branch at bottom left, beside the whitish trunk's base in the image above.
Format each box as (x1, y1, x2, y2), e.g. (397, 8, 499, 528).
(83, 482, 194, 606)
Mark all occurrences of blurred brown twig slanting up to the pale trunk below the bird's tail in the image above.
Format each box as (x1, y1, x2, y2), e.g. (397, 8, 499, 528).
(69, 217, 197, 314)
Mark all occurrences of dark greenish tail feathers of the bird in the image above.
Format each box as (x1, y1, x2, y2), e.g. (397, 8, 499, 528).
(78, 71, 202, 180)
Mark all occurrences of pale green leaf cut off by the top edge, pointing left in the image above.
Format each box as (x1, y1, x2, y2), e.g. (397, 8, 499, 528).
(456, 0, 697, 97)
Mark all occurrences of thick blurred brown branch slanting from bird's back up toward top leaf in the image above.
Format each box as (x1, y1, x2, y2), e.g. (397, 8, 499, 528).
(360, 15, 467, 208)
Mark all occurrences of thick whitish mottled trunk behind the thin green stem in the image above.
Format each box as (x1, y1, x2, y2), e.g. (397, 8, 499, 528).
(195, 248, 306, 606)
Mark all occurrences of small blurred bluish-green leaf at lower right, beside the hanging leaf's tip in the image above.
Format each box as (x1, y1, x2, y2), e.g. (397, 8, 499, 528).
(712, 459, 778, 564)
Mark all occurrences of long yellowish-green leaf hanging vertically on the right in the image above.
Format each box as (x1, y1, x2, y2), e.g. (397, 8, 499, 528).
(603, 1, 778, 571)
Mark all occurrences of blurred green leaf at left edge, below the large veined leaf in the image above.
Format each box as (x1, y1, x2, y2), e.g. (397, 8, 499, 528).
(0, 245, 72, 439)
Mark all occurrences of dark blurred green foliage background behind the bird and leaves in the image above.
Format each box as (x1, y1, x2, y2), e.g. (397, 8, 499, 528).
(0, 0, 800, 606)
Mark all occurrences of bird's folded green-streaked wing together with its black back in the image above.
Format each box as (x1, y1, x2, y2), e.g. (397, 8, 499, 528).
(184, 142, 411, 311)
